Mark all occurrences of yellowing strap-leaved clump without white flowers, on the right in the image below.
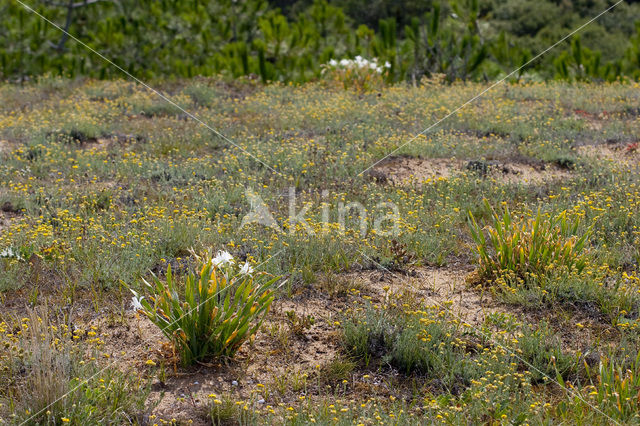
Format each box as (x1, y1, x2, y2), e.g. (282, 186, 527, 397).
(469, 200, 592, 278)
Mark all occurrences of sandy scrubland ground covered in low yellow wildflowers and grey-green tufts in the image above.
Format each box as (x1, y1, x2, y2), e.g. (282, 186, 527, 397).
(0, 79, 640, 424)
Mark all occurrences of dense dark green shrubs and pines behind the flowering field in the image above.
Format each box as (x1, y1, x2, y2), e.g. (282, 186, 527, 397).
(0, 0, 640, 82)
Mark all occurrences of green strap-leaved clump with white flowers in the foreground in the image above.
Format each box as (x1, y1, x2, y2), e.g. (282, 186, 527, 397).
(132, 252, 279, 365)
